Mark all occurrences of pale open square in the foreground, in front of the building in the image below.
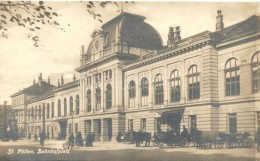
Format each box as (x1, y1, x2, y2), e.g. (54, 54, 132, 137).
(0, 140, 260, 161)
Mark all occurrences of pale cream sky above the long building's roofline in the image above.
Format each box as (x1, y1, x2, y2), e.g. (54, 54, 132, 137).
(0, 1, 260, 104)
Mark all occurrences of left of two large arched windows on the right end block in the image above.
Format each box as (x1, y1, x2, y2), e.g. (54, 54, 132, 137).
(225, 58, 240, 96)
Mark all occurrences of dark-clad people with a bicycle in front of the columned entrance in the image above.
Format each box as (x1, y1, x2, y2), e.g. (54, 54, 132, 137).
(68, 131, 95, 149)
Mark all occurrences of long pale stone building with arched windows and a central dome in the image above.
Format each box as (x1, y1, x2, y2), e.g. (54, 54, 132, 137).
(11, 11, 260, 141)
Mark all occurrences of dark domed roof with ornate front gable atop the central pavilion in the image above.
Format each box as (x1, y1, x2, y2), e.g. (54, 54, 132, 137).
(85, 12, 163, 55)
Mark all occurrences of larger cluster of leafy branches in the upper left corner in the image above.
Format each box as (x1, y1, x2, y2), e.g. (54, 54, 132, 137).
(0, 1, 63, 47)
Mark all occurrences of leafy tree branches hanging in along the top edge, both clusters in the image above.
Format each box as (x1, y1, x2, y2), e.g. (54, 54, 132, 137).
(0, 1, 133, 47)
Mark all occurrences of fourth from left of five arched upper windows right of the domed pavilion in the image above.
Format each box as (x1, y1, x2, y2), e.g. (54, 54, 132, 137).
(170, 70, 181, 102)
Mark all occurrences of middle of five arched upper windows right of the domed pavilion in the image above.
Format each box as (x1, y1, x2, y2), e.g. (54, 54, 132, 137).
(154, 74, 164, 105)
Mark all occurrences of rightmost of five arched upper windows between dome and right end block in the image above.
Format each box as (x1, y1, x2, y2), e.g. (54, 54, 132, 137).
(188, 65, 200, 100)
